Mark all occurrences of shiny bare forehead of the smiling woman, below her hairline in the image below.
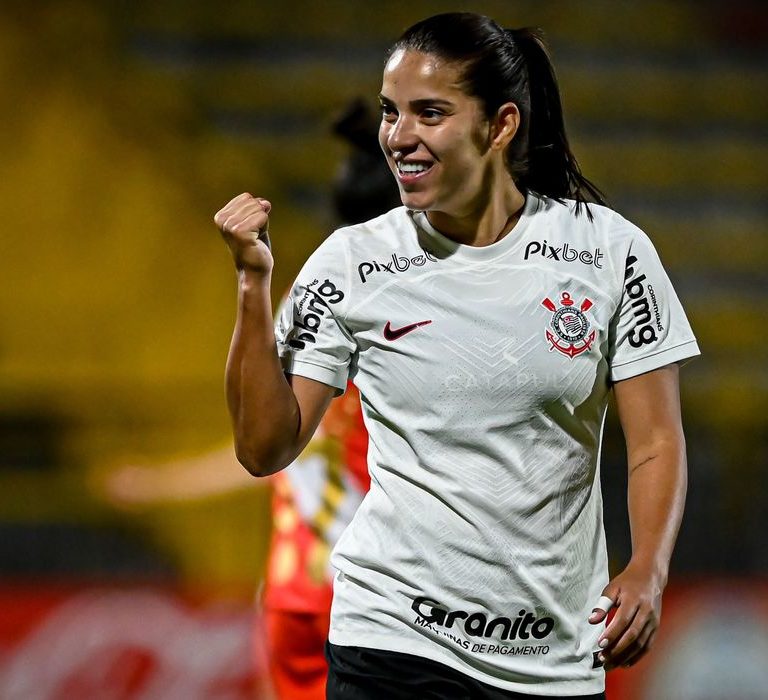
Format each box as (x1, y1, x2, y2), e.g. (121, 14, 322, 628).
(381, 49, 466, 97)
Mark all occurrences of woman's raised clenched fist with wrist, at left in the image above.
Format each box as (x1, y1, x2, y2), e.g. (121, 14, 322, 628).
(214, 192, 274, 275)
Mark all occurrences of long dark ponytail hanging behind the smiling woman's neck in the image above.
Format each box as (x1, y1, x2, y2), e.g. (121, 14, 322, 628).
(505, 28, 605, 220)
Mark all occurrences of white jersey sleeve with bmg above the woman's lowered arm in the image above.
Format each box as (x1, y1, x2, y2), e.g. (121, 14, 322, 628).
(609, 222, 699, 381)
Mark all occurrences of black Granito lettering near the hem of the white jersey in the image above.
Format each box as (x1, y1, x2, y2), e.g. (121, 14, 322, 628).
(411, 596, 555, 641)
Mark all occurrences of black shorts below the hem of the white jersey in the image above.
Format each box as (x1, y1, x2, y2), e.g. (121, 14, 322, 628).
(325, 642, 605, 700)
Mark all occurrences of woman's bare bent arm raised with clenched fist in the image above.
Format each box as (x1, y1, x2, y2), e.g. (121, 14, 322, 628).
(214, 193, 335, 476)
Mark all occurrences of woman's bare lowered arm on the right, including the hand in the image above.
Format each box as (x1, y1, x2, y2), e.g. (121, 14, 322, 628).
(589, 364, 687, 670)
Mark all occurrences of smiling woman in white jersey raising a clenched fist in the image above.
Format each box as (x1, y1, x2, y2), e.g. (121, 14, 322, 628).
(216, 13, 698, 698)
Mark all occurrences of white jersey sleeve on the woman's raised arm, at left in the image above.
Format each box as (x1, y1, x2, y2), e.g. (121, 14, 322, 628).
(275, 234, 356, 393)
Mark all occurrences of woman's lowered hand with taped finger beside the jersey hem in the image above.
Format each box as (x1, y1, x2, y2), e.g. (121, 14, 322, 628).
(589, 563, 663, 671)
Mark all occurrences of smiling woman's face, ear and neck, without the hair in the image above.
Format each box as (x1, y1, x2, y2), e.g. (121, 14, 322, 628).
(379, 50, 525, 246)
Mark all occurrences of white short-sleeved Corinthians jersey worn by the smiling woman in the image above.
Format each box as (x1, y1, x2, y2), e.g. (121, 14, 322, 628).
(277, 195, 698, 696)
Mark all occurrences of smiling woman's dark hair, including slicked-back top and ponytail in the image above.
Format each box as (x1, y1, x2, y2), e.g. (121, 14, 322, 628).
(389, 12, 605, 218)
